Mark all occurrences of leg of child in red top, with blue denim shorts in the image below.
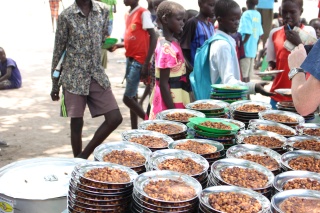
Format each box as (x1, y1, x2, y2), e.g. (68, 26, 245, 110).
(123, 59, 146, 129)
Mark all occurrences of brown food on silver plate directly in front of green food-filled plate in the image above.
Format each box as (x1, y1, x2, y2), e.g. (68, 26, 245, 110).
(175, 140, 217, 155)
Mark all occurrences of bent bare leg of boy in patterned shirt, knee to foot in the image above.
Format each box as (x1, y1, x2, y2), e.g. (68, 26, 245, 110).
(77, 109, 122, 159)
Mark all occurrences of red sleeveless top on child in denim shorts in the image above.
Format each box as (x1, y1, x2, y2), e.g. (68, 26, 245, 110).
(124, 7, 150, 64)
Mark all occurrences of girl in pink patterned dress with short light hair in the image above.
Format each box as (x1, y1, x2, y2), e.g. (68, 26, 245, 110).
(150, 1, 190, 119)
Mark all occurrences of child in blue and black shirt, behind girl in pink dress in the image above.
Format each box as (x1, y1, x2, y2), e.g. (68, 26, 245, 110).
(180, 0, 216, 71)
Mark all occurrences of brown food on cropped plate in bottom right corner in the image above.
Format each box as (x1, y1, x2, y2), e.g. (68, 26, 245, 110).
(280, 197, 320, 213)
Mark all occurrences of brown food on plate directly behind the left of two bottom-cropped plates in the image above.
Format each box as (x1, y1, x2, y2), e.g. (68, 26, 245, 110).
(220, 167, 268, 189)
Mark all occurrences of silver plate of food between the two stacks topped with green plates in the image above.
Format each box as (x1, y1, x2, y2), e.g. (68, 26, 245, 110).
(186, 99, 230, 118)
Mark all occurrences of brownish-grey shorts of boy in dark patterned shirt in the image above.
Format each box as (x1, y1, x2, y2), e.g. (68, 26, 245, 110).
(61, 79, 119, 118)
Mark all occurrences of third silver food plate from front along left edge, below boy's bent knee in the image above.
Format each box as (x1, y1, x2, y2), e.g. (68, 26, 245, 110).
(121, 129, 174, 152)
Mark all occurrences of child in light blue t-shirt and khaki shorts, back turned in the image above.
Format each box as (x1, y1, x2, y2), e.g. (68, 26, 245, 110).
(238, 0, 263, 82)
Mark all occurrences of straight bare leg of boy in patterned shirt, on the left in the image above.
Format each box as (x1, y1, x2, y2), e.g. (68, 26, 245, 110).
(70, 117, 83, 157)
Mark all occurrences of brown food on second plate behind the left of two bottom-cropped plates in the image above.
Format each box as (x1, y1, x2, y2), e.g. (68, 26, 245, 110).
(240, 154, 280, 171)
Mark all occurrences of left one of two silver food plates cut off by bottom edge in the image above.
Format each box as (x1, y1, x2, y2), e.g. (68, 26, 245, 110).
(199, 186, 270, 213)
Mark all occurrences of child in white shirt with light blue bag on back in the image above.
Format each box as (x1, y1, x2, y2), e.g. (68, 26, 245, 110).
(190, 0, 273, 100)
